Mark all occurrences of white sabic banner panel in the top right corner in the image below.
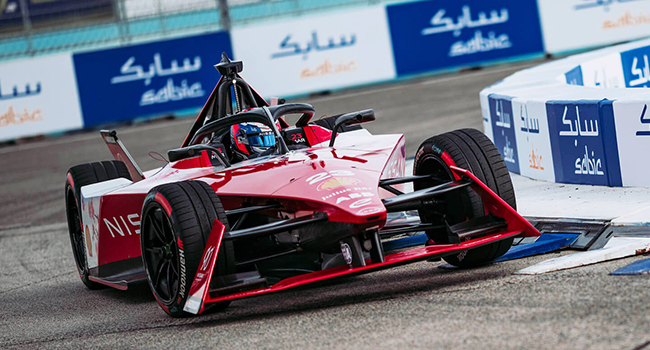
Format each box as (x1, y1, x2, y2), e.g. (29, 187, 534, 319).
(537, 0, 650, 53)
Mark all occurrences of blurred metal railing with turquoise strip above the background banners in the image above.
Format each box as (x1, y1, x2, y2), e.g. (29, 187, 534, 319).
(0, 0, 384, 60)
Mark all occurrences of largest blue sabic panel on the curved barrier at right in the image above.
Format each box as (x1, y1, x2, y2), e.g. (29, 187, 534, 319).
(546, 101, 622, 186)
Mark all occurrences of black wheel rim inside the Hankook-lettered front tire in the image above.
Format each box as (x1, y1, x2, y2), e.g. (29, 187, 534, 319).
(142, 203, 180, 304)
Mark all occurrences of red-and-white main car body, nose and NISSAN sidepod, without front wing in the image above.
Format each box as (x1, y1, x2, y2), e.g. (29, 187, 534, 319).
(92, 131, 404, 270)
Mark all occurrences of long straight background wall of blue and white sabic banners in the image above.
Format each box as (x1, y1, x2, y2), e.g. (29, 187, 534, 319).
(0, 0, 650, 142)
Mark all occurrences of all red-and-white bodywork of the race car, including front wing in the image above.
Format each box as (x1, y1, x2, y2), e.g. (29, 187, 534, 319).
(77, 72, 539, 313)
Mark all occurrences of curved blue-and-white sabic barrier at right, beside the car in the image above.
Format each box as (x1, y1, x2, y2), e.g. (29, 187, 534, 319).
(480, 40, 650, 186)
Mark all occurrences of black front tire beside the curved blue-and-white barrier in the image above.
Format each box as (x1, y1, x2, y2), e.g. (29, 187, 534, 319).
(413, 129, 517, 267)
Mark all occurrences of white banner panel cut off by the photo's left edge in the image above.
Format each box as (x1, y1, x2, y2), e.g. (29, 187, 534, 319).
(0, 54, 83, 140)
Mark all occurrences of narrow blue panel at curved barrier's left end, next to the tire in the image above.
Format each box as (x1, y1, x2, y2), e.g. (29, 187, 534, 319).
(488, 94, 521, 174)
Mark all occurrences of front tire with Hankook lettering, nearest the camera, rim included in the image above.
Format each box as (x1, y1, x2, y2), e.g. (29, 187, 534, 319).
(140, 180, 235, 317)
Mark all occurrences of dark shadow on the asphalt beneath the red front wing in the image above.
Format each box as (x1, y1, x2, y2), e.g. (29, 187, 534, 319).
(183, 265, 506, 328)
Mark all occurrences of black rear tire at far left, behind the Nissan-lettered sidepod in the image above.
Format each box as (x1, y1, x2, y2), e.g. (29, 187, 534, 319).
(65, 160, 131, 289)
